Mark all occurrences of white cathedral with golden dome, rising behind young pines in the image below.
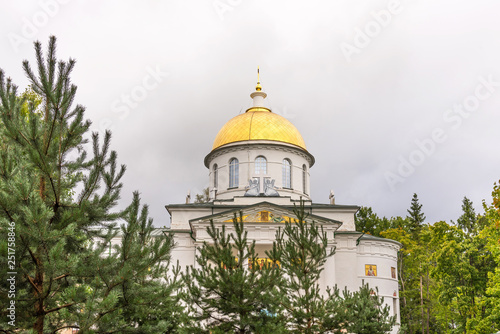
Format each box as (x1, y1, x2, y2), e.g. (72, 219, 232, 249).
(166, 76, 401, 333)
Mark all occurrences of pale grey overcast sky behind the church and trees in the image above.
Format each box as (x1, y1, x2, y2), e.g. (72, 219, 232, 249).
(0, 0, 500, 226)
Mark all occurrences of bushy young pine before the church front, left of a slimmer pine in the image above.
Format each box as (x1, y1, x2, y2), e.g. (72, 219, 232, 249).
(183, 215, 284, 333)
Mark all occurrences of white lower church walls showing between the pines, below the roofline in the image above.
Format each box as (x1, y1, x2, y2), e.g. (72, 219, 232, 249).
(166, 208, 399, 333)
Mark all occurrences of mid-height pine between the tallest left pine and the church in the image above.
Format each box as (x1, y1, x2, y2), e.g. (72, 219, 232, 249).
(70, 192, 186, 334)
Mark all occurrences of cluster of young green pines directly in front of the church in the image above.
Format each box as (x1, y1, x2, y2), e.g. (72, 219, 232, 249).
(183, 203, 395, 333)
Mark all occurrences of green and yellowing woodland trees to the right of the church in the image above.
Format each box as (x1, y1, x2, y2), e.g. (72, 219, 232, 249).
(381, 193, 500, 333)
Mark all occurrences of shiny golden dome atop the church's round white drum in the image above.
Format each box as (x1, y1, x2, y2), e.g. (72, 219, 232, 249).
(212, 107, 307, 151)
